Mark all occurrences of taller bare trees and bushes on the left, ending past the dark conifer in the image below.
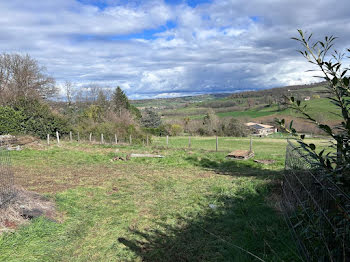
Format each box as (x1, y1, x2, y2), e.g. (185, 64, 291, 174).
(0, 53, 148, 140)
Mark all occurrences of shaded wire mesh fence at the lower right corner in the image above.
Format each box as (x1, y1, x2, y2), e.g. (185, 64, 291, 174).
(282, 141, 350, 261)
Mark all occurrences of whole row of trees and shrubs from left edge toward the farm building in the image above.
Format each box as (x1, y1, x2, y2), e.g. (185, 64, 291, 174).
(0, 53, 252, 142)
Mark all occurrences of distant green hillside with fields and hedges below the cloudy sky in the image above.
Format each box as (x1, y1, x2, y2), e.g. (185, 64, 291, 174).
(133, 82, 339, 132)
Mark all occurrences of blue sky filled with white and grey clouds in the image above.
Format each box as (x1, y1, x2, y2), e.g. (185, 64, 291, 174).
(0, 0, 350, 99)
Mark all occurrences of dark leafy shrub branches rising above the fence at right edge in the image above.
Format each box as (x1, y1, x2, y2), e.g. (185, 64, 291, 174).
(276, 30, 350, 188)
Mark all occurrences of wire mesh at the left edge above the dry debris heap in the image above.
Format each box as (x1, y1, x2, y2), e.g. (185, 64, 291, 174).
(0, 139, 15, 207)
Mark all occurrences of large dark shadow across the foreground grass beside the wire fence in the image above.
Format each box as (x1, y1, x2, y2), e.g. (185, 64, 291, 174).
(118, 177, 299, 261)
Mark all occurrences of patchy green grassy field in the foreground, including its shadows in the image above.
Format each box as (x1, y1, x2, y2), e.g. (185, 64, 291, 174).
(0, 137, 322, 261)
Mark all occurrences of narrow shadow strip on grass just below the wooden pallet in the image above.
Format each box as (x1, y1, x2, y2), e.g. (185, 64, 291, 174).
(186, 156, 282, 176)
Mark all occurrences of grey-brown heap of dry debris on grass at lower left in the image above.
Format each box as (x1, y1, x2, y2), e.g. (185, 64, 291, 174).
(0, 187, 61, 234)
